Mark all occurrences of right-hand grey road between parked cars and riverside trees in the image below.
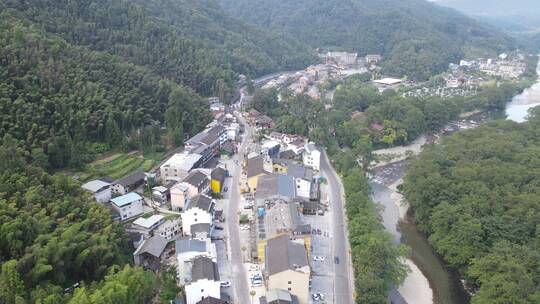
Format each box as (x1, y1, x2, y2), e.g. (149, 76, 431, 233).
(321, 153, 354, 304)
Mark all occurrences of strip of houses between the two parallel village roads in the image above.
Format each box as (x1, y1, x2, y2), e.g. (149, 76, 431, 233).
(241, 132, 322, 304)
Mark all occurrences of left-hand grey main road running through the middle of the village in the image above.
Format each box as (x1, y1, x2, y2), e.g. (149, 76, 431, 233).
(226, 111, 252, 303)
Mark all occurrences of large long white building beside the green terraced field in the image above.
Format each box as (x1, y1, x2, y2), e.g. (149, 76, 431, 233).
(159, 152, 202, 181)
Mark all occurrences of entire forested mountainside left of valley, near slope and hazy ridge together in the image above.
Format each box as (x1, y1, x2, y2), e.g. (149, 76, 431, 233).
(0, 0, 313, 168)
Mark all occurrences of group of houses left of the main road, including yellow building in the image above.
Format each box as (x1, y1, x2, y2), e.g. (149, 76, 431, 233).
(82, 104, 243, 304)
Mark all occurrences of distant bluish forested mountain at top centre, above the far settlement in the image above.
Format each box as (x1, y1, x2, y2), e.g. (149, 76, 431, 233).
(221, 0, 511, 79)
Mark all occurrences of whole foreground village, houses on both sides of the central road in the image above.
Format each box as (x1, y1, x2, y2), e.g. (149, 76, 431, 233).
(78, 91, 348, 304)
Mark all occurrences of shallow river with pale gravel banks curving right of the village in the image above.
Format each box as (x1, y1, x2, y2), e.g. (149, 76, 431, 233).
(370, 58, 540, 304)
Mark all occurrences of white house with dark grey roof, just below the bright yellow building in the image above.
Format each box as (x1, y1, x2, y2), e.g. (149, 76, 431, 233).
(182, 194, 214, 235)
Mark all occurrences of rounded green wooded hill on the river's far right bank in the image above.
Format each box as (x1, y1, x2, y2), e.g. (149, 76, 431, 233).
(402, 108, 540, 304)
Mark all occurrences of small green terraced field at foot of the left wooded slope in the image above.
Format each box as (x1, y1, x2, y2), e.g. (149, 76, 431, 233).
(77, 153, 163, 182)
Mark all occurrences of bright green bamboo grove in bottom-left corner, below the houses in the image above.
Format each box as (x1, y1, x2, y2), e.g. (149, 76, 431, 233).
(0, 135, 131, 303)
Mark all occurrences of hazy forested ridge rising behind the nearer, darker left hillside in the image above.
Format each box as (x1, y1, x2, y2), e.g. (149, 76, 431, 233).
(0, 0, 312, 95)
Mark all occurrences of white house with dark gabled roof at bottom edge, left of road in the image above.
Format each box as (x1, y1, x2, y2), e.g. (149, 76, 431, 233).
(184, 257, 221, 304)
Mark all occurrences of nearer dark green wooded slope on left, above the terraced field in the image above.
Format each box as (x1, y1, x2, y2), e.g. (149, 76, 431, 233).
(0, 12, 210, 168)
